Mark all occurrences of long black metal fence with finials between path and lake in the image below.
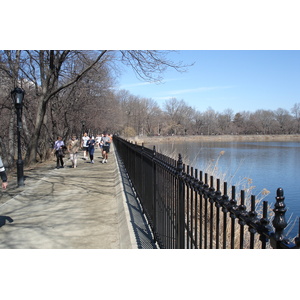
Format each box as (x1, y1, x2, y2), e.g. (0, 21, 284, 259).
(114, 137, 300, 249)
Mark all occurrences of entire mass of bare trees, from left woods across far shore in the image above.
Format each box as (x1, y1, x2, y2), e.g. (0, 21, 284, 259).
(0, 50, 300, 167)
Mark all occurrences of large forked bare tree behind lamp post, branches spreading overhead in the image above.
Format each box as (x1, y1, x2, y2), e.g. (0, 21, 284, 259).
(0, 50, 188, 163)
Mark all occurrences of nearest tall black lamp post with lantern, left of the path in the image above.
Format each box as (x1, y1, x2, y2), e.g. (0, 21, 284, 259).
(11, 88, 25, 186)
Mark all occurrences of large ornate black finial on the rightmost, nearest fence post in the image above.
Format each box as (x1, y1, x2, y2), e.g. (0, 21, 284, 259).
(272, 188, 287, 242)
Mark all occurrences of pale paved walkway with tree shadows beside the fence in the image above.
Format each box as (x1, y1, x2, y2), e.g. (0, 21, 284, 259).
(0, 145, 156, 249)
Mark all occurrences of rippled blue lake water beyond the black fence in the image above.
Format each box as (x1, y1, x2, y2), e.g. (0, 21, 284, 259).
(147, 142, 300, 236)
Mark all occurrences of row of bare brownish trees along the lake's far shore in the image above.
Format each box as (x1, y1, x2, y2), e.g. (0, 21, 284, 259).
(116, 91, 300, 136)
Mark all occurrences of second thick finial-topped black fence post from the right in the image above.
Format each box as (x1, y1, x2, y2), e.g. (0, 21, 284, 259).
(177, 154, 185, 249)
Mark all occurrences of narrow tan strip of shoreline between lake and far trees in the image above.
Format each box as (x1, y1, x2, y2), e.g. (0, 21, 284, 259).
(126, 134, 300, 145)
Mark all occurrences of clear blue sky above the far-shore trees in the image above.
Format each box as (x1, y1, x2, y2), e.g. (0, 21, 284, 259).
(118, 50, 300, 113)
